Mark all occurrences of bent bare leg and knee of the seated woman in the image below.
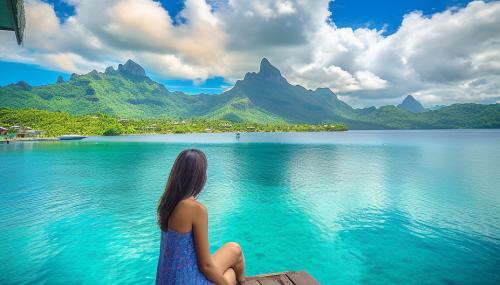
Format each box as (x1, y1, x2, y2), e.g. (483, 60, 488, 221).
(212, 242, 245, 281)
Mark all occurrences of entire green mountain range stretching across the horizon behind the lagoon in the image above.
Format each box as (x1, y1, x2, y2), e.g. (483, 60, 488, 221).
(0, 58, 500, 129)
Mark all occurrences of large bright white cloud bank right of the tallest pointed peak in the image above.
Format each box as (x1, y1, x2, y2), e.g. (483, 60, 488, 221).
(278, 1, 500, 105)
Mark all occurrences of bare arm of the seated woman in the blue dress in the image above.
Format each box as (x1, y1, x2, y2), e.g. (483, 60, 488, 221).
(193, 203, 226, 285)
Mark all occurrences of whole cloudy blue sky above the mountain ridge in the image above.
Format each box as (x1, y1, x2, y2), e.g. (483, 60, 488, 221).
(0, 0, 500, 107)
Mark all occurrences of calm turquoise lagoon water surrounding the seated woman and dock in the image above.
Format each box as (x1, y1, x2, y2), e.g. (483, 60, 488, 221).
(0, 130, 500, 284)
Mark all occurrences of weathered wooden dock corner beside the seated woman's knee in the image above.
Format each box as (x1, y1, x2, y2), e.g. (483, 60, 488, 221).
(240, 271, 319, 285)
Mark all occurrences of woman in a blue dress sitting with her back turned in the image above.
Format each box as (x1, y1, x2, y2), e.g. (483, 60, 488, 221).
(156, 149, 245, 285)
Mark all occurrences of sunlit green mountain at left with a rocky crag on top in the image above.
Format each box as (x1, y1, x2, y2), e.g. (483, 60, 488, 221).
(0, 60, 195, 118)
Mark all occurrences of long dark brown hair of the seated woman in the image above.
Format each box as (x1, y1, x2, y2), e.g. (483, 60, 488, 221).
(157, 149, 207, 231)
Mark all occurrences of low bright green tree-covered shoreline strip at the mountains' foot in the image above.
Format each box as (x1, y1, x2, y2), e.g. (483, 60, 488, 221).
(0, 109, 346, 137)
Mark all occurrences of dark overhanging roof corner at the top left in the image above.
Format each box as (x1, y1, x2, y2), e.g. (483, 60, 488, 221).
(0, 0, 25, 44)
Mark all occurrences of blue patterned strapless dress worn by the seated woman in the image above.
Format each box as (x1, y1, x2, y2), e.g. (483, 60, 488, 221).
(156, 230, 213, 285)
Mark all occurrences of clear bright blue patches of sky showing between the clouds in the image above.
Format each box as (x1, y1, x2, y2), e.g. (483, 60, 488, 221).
(0, 0, 469, 94)
